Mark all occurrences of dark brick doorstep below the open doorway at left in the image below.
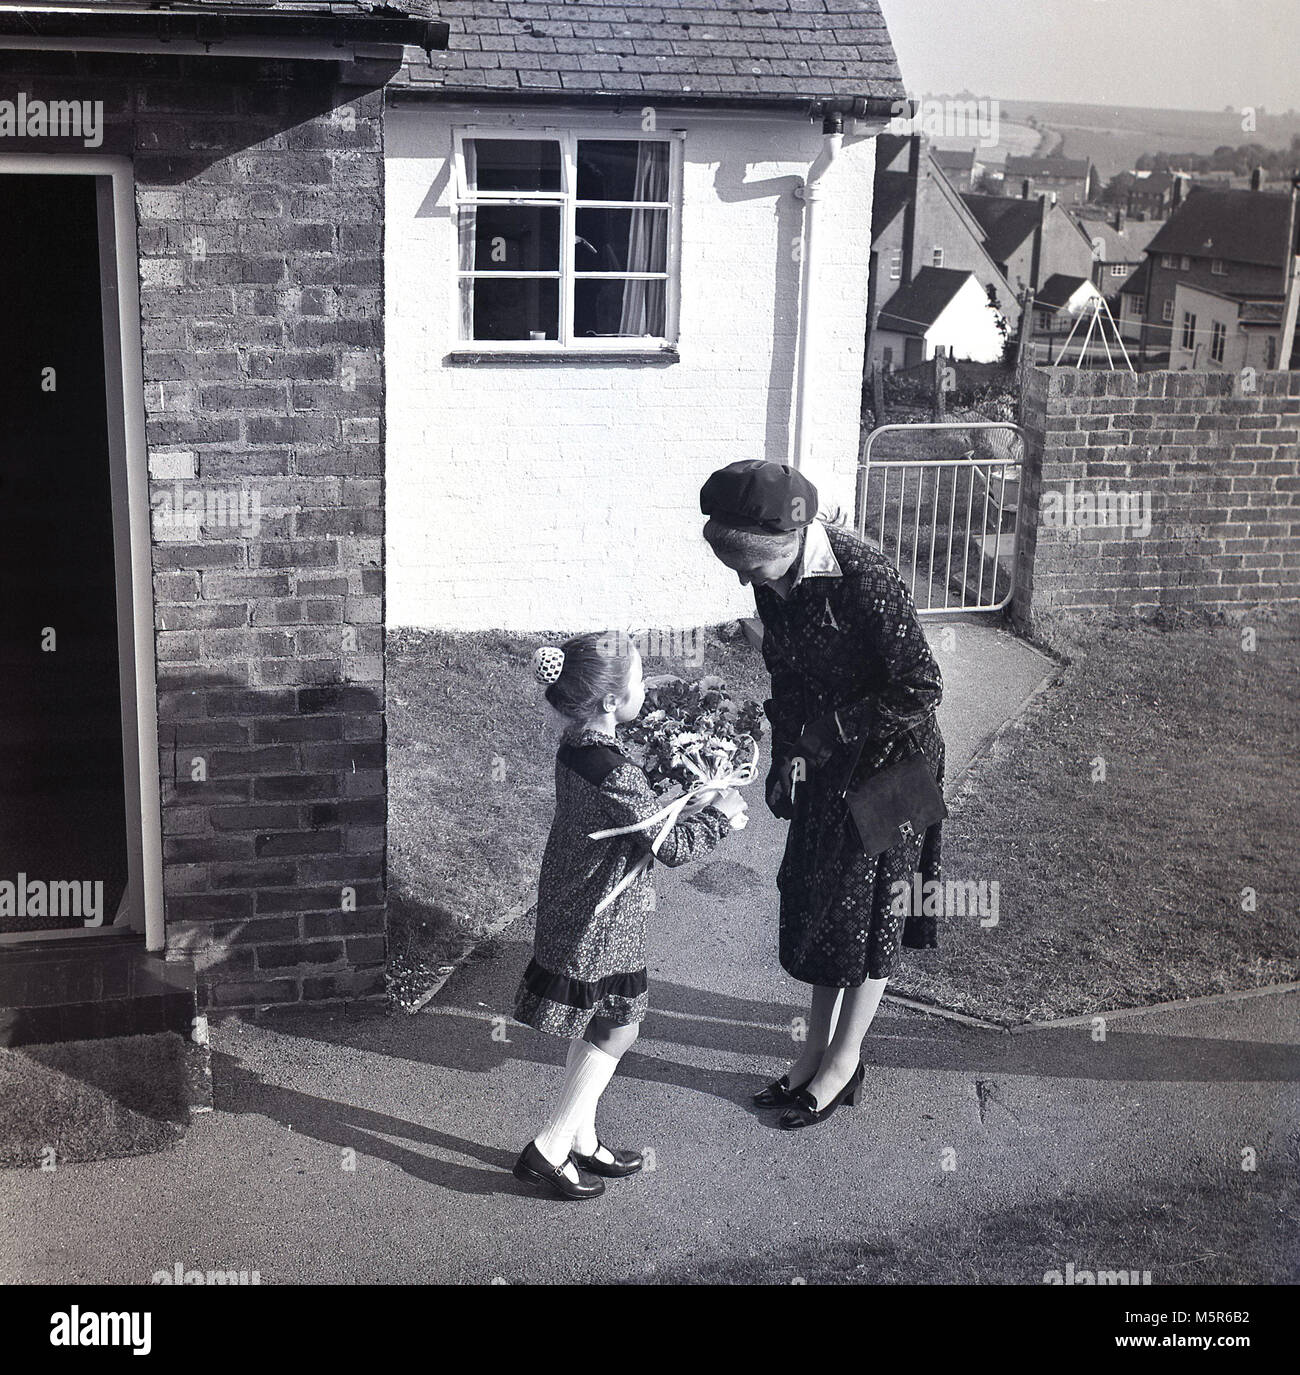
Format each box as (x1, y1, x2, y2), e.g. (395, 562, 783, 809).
(0, 928, 198, 1046)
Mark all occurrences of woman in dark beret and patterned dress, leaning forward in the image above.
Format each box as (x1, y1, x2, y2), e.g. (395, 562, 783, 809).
(700, 461, 944, 1129)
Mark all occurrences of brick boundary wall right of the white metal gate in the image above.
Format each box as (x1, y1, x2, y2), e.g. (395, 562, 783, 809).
(1012, 367, 1300, 633)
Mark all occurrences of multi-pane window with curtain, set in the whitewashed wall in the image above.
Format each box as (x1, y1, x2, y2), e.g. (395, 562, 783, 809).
(457, 129, 680, 351)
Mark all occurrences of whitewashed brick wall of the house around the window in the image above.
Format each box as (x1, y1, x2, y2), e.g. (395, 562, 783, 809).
(385, 105, 875, 631)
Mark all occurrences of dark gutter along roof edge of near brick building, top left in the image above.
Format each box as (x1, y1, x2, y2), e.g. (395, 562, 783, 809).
(0, 6, 450, 56)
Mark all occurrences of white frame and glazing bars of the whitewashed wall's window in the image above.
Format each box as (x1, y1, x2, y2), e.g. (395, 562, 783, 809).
(451, 124, 685, 356)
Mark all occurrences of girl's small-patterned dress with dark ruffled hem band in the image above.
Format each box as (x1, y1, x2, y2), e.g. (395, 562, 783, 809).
(514, 727, 730, 1038)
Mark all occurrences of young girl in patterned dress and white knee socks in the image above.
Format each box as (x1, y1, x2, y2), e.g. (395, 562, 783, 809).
(514, 631, 747, 1199)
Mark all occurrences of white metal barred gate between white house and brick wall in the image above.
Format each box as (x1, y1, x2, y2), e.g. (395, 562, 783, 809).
(857, 421, 1025, 616)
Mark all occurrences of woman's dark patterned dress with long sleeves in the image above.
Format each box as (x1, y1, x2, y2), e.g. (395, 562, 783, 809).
(754, 525, 944, 987)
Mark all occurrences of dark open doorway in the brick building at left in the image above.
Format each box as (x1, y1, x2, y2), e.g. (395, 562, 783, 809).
(0, 173, 128, 932)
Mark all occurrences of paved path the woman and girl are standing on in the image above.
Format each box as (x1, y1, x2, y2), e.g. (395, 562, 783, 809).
(0, 626, 1300, 1283)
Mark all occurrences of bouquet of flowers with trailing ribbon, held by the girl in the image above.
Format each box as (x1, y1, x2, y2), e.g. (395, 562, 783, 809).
(590, 675, 763, 912)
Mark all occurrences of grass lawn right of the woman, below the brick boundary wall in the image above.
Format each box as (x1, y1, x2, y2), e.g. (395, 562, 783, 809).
(890, 623, 1300, 1024)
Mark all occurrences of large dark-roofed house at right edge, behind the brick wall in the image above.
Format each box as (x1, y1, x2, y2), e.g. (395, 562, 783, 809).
(1142, 186, 1300, 367)
